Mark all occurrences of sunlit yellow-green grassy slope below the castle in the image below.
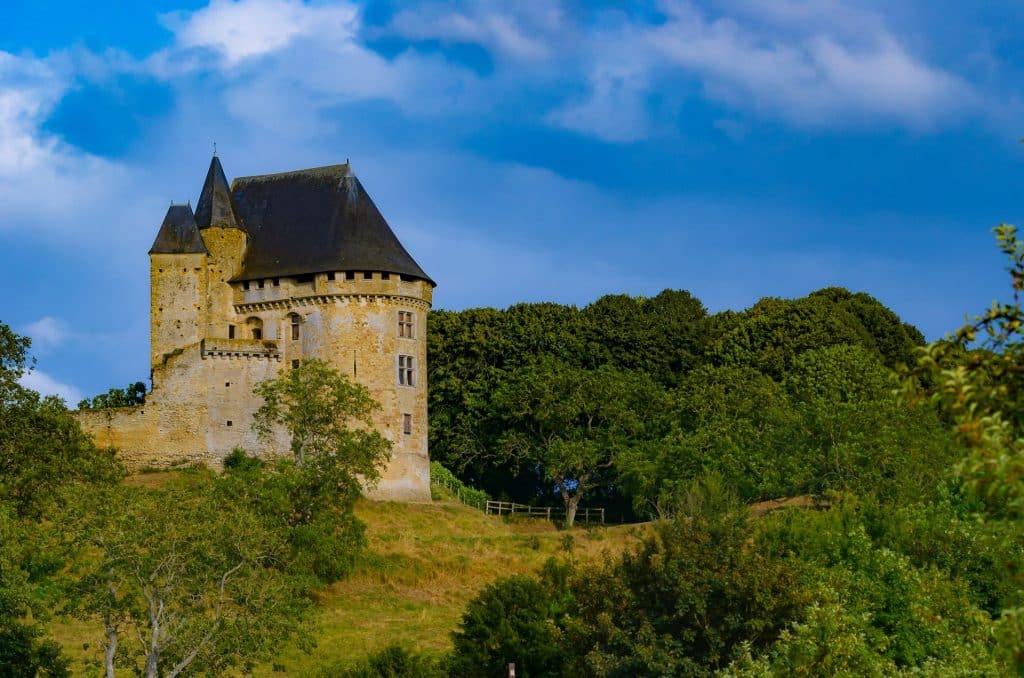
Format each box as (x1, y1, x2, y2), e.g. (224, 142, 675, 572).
(53, 485, 640, 676)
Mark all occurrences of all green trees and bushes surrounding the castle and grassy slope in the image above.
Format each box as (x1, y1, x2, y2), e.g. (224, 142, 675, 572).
(0, 226, 1024, 678)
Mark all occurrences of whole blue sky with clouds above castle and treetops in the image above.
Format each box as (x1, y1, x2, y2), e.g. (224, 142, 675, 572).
(0, 0, 1024, 401)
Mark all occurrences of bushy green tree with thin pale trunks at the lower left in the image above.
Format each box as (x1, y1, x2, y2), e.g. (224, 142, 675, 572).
(63, 471, 310, 678)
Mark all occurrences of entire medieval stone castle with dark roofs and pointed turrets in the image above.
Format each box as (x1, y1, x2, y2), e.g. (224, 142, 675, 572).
(78, 156, 434, 501)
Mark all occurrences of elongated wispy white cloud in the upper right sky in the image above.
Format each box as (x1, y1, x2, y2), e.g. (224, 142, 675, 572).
(646, 2, 975, 128)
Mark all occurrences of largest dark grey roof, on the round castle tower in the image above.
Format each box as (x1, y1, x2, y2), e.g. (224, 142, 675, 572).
(230, 163, 434, 285)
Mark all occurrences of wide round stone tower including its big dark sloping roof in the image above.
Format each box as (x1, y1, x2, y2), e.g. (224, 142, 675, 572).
(228, 164, 434, 501)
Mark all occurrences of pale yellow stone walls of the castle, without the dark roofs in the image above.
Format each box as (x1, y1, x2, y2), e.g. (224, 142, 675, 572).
(79, 268, 432, 501)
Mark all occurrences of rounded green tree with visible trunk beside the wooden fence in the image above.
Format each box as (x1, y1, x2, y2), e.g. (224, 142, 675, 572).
(494, 358, 664, 527)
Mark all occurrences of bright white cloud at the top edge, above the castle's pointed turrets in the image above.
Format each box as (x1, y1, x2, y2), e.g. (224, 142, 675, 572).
(165, 0, 358, 68)
